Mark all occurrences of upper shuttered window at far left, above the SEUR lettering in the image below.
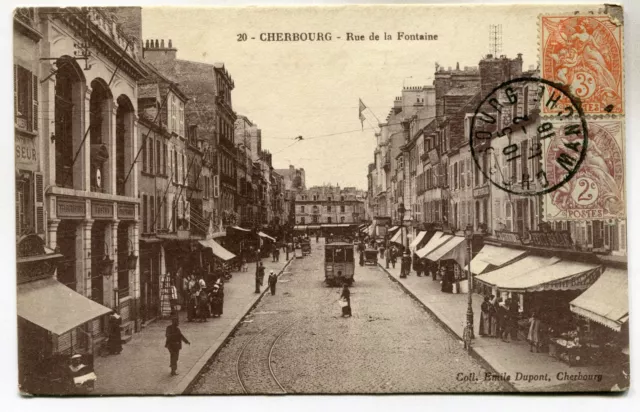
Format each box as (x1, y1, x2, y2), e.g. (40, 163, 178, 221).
(13, 64, 38, 132)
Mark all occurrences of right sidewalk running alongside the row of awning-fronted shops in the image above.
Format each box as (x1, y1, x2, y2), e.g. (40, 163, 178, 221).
(379, 260, 614, 392)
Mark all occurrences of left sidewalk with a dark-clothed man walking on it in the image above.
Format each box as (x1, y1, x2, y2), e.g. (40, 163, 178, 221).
(94, 256, 288, 395)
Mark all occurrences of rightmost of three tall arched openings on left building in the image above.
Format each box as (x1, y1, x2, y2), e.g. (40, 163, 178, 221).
(115, 94, 134, 196)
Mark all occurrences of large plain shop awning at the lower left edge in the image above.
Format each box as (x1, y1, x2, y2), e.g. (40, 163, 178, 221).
(18, 278, 111, 335)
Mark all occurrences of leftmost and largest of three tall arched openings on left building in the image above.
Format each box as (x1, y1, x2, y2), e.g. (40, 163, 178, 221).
(53, 56, 86, 189)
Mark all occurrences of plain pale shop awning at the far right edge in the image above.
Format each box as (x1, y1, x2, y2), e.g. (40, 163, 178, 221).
(569, 268, 629, 332)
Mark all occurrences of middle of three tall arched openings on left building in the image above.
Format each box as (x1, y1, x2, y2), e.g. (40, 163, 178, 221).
(89, 78, 113, 193)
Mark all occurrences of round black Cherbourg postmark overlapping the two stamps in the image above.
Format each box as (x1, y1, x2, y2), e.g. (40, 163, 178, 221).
(469, 77, 588, 196)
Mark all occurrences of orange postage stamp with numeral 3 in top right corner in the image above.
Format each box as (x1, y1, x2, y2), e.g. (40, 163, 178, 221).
(540, 15, 624, 115)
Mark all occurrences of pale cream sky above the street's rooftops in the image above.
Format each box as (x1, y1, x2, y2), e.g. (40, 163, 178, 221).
(142, 5, 592, 189)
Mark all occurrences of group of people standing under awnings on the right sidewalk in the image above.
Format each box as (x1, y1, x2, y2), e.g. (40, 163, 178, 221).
(479, 295, 524, 342)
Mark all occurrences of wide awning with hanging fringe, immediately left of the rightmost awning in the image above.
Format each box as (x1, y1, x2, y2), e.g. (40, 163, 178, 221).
(501, 260, 602, 292)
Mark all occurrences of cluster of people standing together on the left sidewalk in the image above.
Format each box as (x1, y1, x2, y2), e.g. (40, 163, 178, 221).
(181, 275, 224, 322)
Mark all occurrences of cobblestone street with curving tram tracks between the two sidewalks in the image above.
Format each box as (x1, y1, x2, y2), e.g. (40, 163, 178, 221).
(191, 243, 512, 394)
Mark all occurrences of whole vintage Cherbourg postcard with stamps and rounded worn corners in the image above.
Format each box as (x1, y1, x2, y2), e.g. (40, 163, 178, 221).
(13, 4, 630, 396)
